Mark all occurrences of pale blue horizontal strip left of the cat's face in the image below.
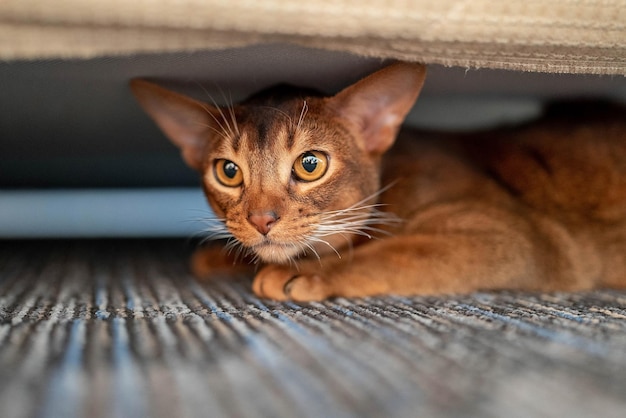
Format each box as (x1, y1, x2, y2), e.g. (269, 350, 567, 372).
(0, 188, 211, 239)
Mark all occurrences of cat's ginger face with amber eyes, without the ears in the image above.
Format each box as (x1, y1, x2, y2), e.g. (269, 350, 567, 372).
(201, 98, 379, 263)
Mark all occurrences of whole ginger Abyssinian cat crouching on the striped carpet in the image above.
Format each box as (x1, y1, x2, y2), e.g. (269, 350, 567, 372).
(131, 63, 626, 301)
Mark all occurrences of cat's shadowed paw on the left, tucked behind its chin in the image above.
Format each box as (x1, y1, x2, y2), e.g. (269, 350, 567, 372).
(190, 244, 255, 280)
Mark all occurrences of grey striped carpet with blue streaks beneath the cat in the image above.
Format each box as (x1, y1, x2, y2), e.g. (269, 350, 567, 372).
(0, 240, 626, 418)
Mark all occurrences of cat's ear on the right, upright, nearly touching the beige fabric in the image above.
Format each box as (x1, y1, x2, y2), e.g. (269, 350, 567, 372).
(329, 63, 426, 154)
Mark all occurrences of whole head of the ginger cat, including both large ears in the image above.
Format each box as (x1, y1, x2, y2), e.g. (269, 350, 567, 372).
(131, 63, 425, 263)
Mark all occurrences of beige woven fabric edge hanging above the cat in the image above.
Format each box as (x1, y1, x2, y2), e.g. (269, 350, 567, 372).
(0, 0, 626, 75)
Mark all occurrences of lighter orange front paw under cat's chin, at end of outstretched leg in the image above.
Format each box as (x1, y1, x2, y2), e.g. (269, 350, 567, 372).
(252, 265, 331, 302)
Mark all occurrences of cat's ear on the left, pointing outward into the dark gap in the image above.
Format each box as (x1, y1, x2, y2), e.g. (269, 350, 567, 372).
(130, 79, 219, 170)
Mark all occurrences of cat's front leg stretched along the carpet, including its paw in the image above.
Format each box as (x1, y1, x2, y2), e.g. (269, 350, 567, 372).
(253, 224, 576, 301)
